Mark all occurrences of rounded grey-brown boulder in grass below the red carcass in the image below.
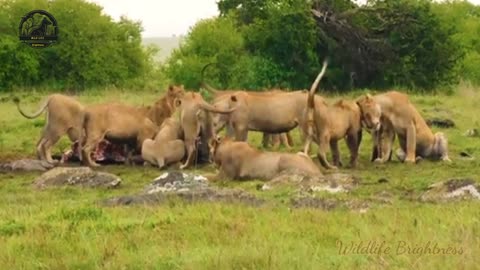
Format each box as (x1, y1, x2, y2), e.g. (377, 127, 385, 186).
(33, 167, 122, 188)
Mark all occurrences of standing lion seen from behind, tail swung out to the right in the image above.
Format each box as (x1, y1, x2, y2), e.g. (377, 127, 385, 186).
(175, 92, 235, 169)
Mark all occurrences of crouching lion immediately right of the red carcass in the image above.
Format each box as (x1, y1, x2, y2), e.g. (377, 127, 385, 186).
(142, 118, 185, 169)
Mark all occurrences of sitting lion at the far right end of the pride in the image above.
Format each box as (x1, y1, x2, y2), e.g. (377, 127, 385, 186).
(357, 91, 451, 163)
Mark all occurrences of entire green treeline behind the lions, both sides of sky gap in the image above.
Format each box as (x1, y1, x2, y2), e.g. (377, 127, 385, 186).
(0, 0, 480, 91)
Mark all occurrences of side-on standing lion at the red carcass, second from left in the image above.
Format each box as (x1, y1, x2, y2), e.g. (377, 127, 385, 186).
(80, 103, 159, 167)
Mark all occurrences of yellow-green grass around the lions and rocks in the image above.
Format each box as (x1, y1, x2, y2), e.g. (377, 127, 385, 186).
(0, 86, 480, 269)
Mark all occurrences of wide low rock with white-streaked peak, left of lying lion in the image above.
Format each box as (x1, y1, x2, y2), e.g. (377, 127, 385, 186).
(101, 171, 264, 206)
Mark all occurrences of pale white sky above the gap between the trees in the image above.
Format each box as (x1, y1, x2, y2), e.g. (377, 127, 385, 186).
(89, 0, 480, 37)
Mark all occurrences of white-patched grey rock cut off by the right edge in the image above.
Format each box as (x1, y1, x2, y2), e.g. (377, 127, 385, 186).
(420, 178, 480, 202)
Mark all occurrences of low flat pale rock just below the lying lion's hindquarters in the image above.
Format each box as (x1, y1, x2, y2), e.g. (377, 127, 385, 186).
(261, 172, 359, 193)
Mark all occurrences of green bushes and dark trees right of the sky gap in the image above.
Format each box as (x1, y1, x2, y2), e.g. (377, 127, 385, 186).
(166, 0, 480, 91)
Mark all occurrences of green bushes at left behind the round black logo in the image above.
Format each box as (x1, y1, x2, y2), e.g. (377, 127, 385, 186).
(0, 0, 161, 91)
